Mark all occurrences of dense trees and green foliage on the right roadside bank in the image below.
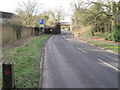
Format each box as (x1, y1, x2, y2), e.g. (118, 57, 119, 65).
(72, 0, 120, 41)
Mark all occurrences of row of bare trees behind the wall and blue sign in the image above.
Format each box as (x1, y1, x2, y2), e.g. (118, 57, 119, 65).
(15, 0, 64, 27)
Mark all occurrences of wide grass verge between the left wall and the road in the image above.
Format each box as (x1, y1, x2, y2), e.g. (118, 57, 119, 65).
(0, 35, 50, 88)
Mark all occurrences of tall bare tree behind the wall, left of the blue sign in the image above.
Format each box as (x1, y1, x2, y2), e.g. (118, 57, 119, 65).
(16, 0, 39, 27)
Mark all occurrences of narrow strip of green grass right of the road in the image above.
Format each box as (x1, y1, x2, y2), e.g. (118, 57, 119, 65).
(88, 41, 120, 53)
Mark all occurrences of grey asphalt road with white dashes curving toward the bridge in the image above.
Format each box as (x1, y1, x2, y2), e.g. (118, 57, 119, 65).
(42, 31, 119, 88)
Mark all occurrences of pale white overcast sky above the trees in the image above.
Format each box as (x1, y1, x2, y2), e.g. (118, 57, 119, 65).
(0, 0, 119, 19)
